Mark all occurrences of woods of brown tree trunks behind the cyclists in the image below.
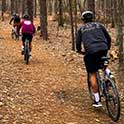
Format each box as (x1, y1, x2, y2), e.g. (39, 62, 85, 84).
(0, 0, 124, 67)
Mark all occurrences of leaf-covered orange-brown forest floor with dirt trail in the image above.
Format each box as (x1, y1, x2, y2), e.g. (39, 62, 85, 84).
(0, 16, 124, 124)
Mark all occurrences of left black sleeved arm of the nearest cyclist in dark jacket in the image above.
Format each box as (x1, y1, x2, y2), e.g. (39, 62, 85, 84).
(76, 29, 82, 53)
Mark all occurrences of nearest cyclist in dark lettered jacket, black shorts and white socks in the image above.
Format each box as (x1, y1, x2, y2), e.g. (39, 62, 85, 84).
(76, 11, 111, 107)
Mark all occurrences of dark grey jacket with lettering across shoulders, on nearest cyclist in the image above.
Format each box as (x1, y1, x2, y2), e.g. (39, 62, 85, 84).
(76, 22, 111, 54)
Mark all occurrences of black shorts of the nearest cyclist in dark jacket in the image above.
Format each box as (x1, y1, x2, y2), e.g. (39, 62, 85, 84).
(84, 50, 107, 72)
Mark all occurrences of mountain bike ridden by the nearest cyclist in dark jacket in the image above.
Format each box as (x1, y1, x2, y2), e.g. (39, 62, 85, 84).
(88, 57, 120, 122)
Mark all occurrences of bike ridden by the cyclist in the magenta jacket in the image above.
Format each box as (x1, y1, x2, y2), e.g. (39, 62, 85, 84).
(24, 39, 30, 64)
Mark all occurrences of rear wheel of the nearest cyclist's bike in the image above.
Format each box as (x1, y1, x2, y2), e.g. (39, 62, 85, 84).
(106, 78, 120, 121)
